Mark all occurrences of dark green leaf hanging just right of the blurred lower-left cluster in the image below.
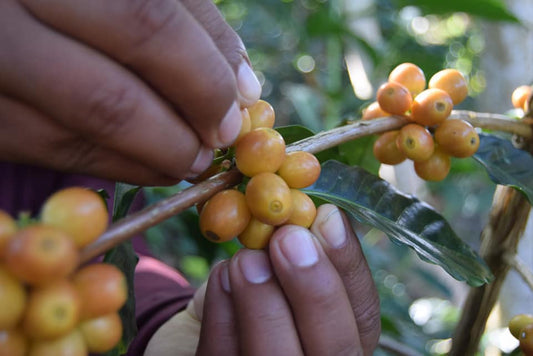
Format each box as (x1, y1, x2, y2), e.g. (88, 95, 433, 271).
(104, 183, 141, 356)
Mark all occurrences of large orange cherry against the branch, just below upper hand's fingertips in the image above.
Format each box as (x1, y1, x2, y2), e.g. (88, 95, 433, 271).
(235, 127, 285, 177)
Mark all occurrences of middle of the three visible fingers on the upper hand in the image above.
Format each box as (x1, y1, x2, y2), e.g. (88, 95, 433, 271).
(22, 0, 242, 148)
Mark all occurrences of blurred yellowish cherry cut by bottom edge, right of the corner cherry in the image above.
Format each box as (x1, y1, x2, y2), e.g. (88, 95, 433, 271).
(28, 329, 89, 356)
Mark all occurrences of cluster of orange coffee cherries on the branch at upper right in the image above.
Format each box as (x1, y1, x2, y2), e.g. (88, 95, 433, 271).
(362, 63, 479, 181)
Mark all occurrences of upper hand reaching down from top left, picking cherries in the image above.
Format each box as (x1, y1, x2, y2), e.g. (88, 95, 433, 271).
(0, 0, 261, 185)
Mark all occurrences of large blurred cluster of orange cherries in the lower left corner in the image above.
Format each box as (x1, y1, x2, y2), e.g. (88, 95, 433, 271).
(0, 187, 127, 356)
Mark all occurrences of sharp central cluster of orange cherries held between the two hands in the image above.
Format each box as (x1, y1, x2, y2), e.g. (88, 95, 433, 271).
(196, 100, 320, 249)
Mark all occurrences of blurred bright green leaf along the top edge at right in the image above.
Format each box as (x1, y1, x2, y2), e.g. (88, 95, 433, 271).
(398, 0, 520, 23)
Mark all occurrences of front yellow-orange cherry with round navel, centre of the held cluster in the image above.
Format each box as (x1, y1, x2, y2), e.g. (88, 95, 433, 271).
(244, 172, 293, 226)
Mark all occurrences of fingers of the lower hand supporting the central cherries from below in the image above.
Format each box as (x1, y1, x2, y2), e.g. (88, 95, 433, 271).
(197, 205, 380, 356)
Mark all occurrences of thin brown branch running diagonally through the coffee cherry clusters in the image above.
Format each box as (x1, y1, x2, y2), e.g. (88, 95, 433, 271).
(81, 111, 533, 263)
